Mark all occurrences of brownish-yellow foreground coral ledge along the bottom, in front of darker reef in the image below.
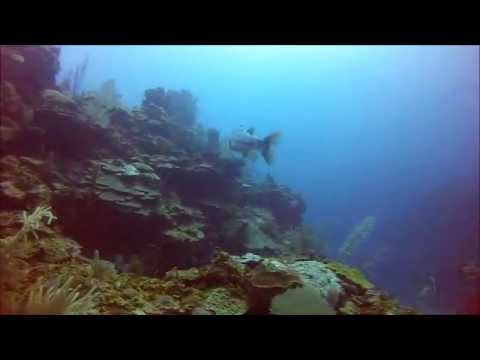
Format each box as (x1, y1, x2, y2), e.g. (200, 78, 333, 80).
(0, 221, 411, 315)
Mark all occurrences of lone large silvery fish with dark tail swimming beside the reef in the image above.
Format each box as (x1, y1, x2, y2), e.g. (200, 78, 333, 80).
(228, 128, 280, 165)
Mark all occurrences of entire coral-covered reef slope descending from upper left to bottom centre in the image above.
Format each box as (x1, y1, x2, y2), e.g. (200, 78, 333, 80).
(0, 46, 410, 315)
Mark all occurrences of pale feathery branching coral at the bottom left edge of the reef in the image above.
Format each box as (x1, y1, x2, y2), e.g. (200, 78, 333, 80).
(19, 276, 98, 315)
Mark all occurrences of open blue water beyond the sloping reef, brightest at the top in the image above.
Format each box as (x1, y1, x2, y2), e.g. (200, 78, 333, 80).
(59, 46, 480, 312)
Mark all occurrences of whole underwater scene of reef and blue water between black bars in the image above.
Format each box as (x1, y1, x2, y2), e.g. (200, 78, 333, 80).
(0, 45, 480, 315)
